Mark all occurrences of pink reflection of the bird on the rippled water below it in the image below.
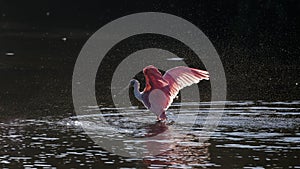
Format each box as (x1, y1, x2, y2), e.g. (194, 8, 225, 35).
(143, 122, 209, 168)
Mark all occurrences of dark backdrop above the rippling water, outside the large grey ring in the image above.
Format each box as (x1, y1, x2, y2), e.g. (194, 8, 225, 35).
(0, 0, 300, 117)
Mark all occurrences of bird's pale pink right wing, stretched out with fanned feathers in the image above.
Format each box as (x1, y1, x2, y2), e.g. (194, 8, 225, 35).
(163, 66, 209, 99)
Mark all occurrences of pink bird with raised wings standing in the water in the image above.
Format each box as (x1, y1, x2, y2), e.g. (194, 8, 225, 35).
(130, 65, 209, 121)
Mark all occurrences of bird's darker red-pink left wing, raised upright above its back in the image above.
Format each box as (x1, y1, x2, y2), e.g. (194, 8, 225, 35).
(143, 65, 168, 92)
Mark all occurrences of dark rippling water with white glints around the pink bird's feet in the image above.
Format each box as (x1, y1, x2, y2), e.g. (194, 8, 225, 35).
(0, 101, 300, 168)
